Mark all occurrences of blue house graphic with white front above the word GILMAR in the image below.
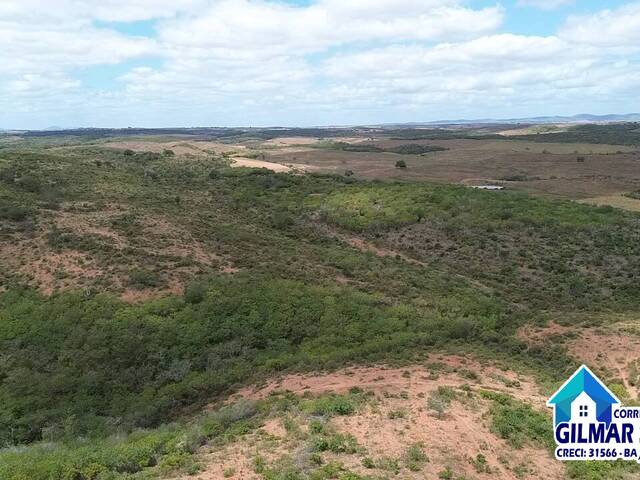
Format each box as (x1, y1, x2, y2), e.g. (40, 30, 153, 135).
(547, 365, 620, 426)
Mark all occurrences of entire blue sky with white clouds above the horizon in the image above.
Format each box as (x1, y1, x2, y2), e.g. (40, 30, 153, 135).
(0, 0, 640, 129)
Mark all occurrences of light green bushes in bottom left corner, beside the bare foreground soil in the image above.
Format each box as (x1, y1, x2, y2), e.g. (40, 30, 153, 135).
(0, 402, 260, 480)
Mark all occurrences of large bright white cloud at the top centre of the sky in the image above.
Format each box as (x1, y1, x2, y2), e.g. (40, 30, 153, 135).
(159, 0, 503, 54)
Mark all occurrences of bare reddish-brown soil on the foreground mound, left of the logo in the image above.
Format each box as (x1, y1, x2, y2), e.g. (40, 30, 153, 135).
(172, 355, 564, 480)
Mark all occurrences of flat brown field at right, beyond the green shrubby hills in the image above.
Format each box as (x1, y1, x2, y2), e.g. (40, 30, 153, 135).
(265, 140, 640, 199)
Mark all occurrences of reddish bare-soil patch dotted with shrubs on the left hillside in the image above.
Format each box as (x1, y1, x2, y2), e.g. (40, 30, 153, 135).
(0, 202, 238, 302)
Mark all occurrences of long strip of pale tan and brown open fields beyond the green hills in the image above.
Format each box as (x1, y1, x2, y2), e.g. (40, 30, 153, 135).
(79, 137, 640, 200)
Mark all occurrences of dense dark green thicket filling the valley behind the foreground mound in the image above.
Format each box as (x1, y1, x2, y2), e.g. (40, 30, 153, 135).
(0, 277, 501, 444)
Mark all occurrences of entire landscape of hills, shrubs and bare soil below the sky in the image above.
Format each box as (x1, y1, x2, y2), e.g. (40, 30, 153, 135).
(0, 126, 640, 480)
